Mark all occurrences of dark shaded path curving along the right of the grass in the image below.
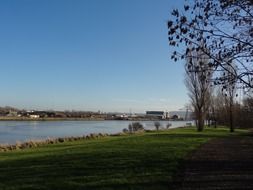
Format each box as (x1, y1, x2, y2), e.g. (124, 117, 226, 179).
(171, 136, 253, 190)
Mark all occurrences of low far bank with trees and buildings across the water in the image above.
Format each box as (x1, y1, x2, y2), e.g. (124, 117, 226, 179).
(0, 106, 190, 121)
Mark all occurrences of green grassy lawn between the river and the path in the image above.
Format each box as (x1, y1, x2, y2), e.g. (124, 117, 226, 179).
(0, 128, 245, 190)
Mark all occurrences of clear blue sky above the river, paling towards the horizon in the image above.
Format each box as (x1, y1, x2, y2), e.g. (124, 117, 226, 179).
(0, 0, 188, 112)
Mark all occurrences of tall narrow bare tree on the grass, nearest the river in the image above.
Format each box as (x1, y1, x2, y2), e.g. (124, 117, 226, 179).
(185, 46, 212, 131)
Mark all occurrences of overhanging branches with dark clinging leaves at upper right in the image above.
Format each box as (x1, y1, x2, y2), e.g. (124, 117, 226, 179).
(168, 0, 253, 89)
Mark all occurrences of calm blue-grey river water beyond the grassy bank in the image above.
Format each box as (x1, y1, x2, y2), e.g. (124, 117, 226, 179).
(0, 120, 193, 144)
